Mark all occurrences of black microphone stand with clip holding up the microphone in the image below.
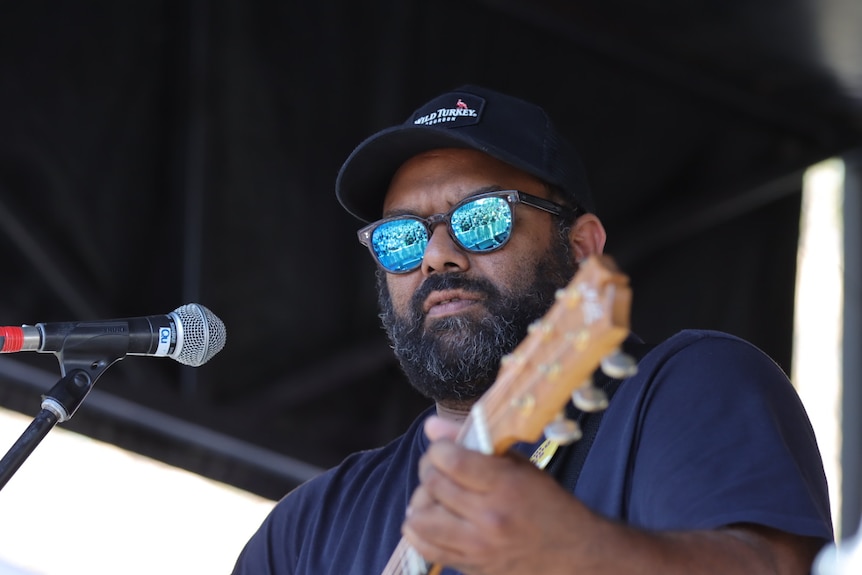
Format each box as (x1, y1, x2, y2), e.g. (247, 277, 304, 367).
(0, 336, 129, 489)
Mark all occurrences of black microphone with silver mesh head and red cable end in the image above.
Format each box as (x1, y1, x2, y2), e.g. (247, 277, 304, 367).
(0, 303, 227, 367)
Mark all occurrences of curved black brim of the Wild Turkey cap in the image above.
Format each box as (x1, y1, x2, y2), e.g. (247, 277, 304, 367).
(335, 126, 505, 222)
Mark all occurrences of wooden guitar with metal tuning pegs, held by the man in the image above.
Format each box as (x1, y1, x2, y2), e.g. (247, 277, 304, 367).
(382, 256, 636, 575)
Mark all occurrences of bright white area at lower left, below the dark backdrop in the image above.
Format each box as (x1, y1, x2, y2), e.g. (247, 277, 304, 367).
(0, 408, 273, 575)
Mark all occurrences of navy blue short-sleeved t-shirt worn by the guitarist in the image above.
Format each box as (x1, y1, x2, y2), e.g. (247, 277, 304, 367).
(234, 330, 832, 575)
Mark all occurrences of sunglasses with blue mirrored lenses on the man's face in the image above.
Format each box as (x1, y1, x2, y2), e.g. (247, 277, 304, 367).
(358, 190, 581, 274)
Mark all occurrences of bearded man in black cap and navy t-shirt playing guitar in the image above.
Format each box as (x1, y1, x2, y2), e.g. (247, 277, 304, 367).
(235, 86, 832, 575)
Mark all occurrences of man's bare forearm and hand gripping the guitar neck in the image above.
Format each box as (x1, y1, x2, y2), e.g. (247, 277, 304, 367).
(403, 418, 822, 575)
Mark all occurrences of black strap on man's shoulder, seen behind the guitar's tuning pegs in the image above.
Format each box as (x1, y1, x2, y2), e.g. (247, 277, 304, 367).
(546, 340, 655, 493)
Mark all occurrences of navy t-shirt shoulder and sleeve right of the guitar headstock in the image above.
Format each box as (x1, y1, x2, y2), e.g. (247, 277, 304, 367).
(596, 330, 831, 538)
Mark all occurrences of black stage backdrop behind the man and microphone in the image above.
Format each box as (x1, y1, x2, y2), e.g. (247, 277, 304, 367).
(0, 0, 862, 497)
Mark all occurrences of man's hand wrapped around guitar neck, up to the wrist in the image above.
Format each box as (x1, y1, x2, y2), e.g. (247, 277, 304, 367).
(403, 417, 599, 575)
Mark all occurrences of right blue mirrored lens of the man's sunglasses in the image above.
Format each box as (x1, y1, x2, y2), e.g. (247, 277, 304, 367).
(450, 198, 512, 252)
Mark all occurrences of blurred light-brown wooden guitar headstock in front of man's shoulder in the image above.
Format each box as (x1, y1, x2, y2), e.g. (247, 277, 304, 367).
(478, 256, 631, 453)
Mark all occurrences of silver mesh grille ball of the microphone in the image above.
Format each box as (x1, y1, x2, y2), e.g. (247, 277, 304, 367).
(171, 303, 227, 367)
